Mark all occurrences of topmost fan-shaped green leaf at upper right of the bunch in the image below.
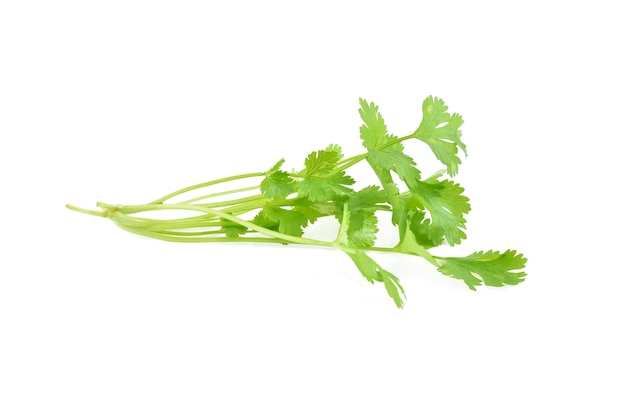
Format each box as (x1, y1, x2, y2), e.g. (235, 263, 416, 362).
(413, 96, 467, 176)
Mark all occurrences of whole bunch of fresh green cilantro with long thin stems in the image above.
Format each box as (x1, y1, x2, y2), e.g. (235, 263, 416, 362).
(67, 97, 526, 308)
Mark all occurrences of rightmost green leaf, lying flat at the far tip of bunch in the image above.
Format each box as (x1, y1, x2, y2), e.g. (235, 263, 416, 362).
(439, 250, 527, 290)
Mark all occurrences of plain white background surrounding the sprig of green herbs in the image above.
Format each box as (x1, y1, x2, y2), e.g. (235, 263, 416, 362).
(0, 0, 626, 418)
